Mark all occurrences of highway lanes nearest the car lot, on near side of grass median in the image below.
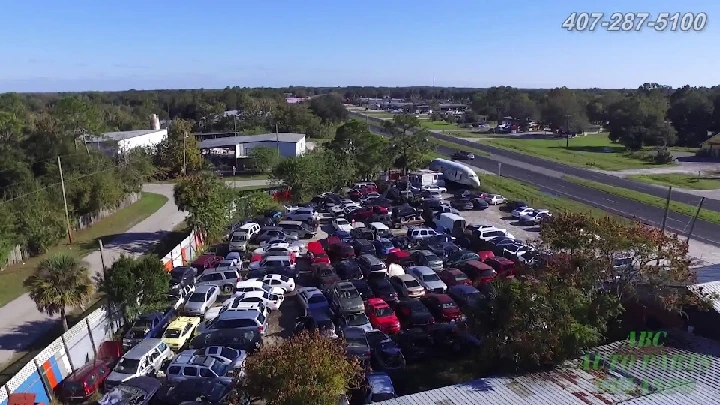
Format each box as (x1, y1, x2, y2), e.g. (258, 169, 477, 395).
(358, 113, 720, 247)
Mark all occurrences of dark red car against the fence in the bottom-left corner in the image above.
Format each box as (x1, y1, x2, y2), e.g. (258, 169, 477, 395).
(56, 341, 122, 402)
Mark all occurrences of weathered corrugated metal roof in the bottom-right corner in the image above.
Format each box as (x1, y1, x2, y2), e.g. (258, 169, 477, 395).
(381, 333, 720, 405)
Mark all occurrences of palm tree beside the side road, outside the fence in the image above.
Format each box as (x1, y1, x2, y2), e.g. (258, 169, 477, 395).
(25, 254, 93, 331)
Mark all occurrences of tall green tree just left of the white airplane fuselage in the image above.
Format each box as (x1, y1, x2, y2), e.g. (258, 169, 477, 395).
(383, 114, 434, 173)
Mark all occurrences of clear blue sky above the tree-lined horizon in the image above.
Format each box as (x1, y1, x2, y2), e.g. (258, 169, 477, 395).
(0, 0, 720, 92)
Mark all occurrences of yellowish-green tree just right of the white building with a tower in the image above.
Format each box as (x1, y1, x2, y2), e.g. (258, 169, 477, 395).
(154, 119, 204, 178)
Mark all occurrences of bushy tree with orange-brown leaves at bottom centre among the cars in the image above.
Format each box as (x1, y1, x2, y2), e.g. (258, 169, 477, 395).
(242, 333, 361, 405)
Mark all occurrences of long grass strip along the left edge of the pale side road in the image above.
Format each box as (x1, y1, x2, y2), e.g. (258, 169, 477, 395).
(0, 193, 167, 306)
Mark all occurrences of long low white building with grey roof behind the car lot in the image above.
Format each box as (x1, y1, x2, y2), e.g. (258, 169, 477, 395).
(200, 133, 307, 159)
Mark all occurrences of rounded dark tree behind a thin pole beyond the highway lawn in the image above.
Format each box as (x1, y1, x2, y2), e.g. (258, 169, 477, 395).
(542, 87, 588, 132)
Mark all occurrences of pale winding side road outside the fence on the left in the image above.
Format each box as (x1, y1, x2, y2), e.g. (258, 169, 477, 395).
(0, 180, 267, 365)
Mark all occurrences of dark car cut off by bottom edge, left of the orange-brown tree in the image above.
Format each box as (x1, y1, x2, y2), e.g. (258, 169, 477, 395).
(153, 378, 232, 405)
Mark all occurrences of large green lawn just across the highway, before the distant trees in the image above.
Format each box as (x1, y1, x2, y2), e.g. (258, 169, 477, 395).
(482, 132, 676, 170)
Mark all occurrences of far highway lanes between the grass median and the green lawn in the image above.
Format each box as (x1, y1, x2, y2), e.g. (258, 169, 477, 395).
(355, 110, 720, 211)
